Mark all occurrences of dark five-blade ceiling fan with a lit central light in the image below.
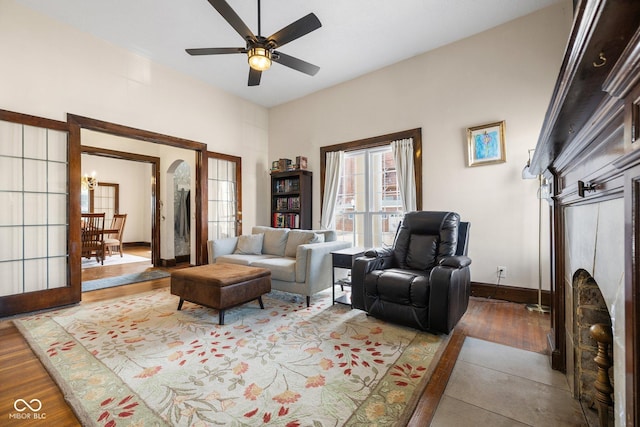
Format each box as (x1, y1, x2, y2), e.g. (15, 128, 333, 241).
(186, 0, 322, 86)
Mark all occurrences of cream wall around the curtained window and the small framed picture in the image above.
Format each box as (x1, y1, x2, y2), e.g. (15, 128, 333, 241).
(268, 0, 572, 289)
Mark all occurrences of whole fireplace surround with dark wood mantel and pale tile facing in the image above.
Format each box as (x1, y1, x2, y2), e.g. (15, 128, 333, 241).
(531, 0, 640, 425)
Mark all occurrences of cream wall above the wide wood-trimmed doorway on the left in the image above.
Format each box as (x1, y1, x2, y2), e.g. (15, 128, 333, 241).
(0, 0, 268, 244)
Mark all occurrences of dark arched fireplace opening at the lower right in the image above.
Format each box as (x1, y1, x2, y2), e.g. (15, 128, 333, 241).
(573, 269, 614, 427)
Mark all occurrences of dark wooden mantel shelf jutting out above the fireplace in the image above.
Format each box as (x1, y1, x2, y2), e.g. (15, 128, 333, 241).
(530, 0, 640, 173)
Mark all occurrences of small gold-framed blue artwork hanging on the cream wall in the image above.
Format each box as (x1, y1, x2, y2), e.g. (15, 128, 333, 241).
(467, 120, 507, 166)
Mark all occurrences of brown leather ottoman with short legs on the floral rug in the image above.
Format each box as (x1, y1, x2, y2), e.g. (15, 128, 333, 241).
(171, 264, 271, 325)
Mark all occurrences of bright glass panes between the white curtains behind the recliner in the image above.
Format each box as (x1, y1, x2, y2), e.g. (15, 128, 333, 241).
(335, 145, 404, 248)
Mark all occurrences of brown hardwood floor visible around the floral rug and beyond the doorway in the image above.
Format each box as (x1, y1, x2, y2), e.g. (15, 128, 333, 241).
(0, 252, 549, 426)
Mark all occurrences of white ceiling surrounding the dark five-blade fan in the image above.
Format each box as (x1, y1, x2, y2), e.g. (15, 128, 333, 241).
(17, 0, 562, 107)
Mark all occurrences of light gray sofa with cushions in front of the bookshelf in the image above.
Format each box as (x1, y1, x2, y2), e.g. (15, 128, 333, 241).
(207, 226, 351, 307)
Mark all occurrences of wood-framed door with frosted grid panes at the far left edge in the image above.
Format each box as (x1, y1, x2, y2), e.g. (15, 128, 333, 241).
(0, 110, 80, 317)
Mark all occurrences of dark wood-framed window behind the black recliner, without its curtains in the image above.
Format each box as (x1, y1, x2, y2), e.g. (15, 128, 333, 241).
(320, 129, 422, 247)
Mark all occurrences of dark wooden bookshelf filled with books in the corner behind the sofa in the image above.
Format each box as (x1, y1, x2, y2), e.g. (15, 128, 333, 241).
(271, 170, 313, 230)
